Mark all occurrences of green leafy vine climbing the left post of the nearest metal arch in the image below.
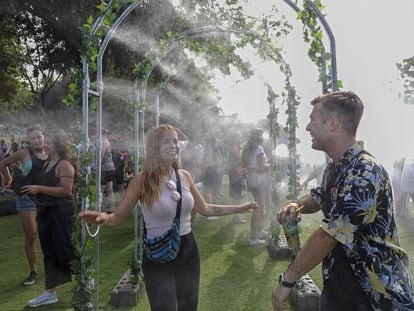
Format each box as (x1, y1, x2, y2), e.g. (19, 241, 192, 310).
(63, 0, 134, 311)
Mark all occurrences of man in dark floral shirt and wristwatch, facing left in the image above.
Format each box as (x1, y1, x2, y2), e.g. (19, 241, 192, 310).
(273, 92, 414, 311)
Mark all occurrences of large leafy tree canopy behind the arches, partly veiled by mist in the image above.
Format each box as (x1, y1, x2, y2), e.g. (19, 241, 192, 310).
(0, 0, 290, 139)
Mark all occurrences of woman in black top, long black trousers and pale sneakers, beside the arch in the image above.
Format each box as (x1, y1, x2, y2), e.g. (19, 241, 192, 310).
(22, 129, 75, 307)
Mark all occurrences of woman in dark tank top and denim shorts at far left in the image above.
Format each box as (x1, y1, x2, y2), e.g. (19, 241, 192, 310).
(0, 124, 47, 285)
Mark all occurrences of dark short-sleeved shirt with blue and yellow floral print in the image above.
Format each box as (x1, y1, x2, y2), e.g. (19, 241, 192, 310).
(311, 143, 414, 310)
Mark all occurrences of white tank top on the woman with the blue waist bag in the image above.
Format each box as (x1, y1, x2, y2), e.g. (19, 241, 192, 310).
(142, 172, 194, 239)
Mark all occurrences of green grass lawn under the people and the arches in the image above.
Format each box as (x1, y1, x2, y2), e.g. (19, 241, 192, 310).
(0, 195, 414, 311)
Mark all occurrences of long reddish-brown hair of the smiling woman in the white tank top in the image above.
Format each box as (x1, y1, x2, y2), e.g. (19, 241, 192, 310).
(140, 124, 179, 207)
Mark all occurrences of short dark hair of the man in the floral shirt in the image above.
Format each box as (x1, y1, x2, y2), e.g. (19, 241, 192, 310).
(311, 91, 364, 136)
